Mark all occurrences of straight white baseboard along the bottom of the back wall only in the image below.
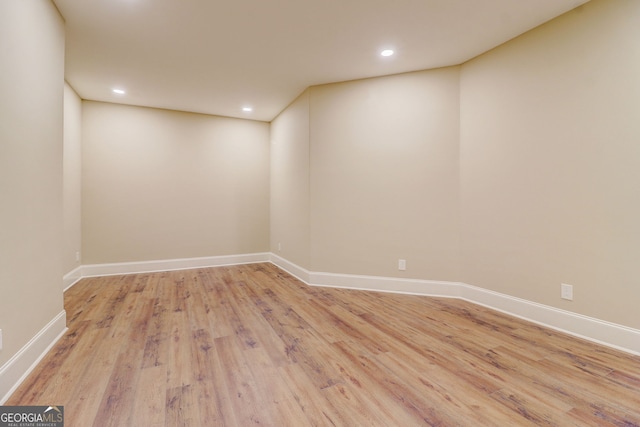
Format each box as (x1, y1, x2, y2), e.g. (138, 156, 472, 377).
(82, 252, 269, 277)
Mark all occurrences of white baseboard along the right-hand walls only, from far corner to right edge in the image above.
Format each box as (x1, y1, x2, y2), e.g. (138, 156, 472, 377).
(271, 254, 640, 355)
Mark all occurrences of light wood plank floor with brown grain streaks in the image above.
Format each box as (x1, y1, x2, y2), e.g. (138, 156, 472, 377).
(7, 264, 640, 427)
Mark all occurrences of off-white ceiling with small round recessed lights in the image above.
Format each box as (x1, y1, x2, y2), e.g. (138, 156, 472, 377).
(54, 0, 588, 121)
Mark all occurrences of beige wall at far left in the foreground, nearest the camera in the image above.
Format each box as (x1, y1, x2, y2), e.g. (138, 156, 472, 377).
(0, 1, 64, 366)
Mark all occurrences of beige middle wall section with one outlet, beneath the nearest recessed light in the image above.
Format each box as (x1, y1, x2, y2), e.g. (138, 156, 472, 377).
(310, 67, 459, 280)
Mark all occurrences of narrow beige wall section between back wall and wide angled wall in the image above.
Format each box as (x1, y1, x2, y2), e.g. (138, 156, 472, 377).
(271, 90, 310, 269)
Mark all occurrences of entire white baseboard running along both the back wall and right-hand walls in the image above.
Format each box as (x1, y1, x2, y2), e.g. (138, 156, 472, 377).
(56, 252, 640, 355)
